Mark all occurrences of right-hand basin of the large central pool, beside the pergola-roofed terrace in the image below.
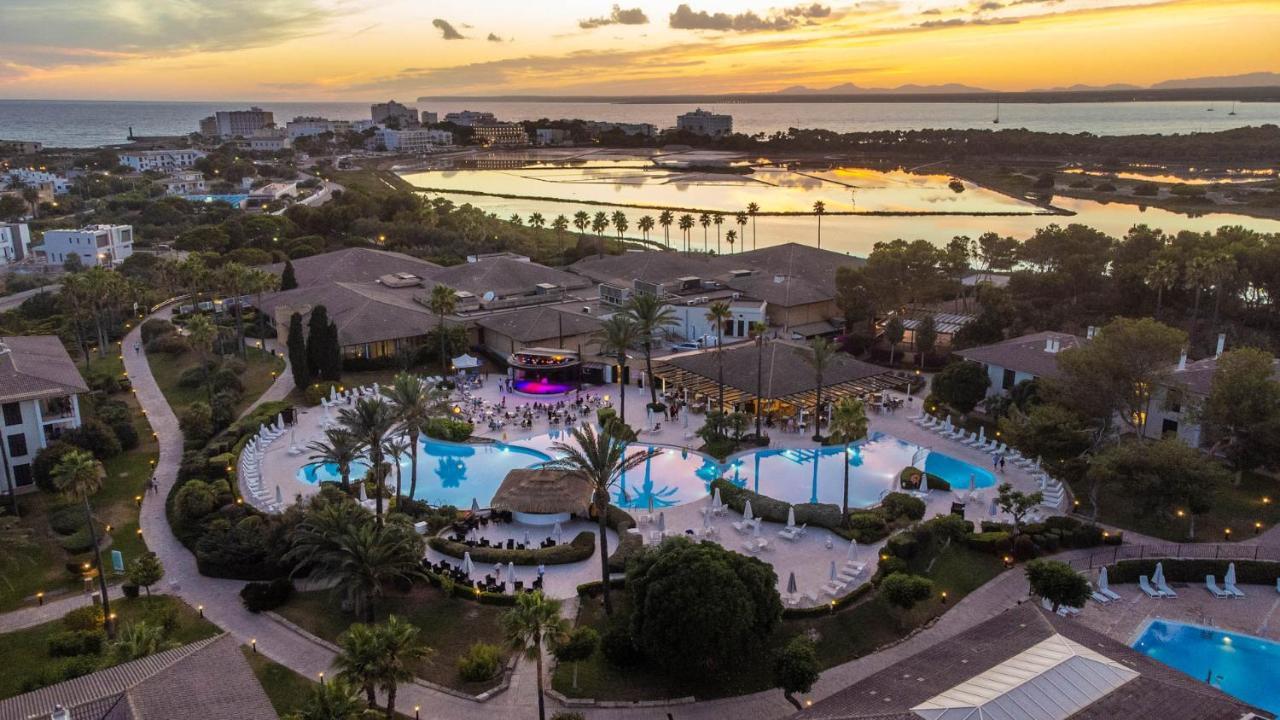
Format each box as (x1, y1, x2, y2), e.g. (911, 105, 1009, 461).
(724, 433, 996, 507)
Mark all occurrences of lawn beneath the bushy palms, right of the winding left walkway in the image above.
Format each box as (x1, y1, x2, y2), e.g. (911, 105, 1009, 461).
(278, 584, 509, 694)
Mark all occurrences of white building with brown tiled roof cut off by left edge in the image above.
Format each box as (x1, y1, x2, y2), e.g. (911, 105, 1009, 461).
(0, 336, 88, 493)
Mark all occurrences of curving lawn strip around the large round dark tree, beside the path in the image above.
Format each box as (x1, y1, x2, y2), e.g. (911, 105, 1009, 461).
(552, 544, 1004, 701)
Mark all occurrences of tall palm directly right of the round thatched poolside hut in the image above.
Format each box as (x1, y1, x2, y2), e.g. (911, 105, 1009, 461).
(543, 424, 655, 615)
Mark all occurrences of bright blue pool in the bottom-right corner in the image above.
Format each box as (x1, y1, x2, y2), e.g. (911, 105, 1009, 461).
(1133, 619, 1280, 714)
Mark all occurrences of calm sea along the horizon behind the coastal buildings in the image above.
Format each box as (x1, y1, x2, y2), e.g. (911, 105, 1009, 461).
(0, 99, 1280, 147)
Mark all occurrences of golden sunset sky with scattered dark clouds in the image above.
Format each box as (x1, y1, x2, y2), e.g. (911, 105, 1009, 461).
(0, 0, 1280, 100)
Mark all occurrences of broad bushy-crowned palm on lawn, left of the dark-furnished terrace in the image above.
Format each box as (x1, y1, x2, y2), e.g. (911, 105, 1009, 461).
(285, 512, 424, 623)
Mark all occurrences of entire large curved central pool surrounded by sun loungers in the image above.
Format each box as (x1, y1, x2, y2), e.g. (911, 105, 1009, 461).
(298, 432, 996, 509)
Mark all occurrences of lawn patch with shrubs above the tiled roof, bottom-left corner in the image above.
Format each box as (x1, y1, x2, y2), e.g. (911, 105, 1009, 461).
(0, 596, 220, 697)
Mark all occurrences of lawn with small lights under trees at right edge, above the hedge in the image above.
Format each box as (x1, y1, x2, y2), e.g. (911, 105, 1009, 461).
(1076, 473, 1280, 542)
